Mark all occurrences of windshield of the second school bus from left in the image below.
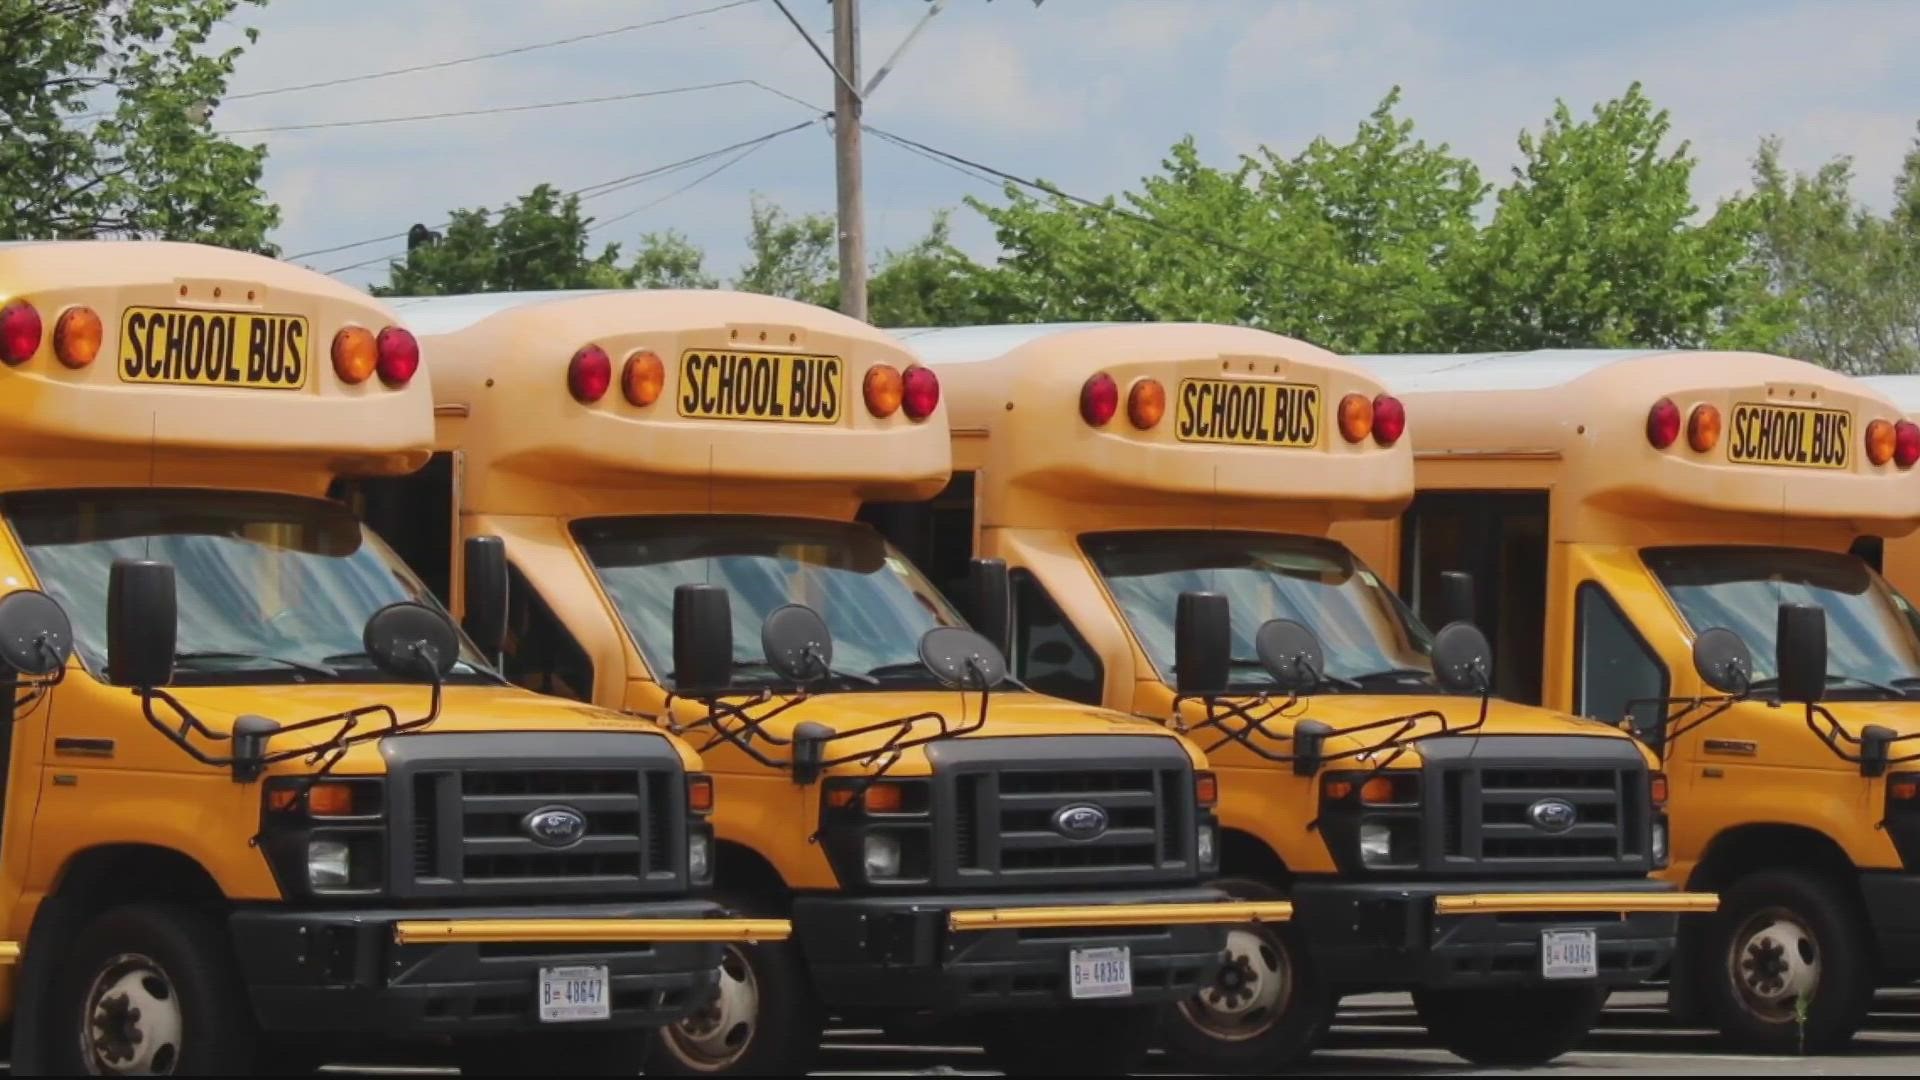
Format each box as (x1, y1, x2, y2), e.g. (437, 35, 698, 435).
(574, 515, 962, 690)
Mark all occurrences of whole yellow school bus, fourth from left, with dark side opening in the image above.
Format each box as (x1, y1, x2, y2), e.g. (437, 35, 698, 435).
(1354, 352, 1920, 1053)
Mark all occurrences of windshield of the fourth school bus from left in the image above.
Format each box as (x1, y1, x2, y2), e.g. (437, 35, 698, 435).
(1642, 548, 1920, 698)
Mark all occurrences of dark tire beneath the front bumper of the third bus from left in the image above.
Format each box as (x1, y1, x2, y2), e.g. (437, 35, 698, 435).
(1413, 986, 1609, 1068)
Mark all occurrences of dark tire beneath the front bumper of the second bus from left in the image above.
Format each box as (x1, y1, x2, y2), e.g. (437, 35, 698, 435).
(975, 1005, 1165, 1076)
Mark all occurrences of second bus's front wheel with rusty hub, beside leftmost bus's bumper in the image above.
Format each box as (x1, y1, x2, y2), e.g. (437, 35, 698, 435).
(647, 887, 826, 1076)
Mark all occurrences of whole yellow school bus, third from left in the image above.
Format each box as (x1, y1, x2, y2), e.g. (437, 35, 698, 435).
(874, 325, 1713, 1072)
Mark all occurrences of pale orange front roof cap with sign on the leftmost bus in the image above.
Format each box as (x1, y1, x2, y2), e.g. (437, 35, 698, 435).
(0, 240, 432, 494)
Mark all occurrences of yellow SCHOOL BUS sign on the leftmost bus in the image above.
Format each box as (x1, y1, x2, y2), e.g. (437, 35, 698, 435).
(119, 307, 313, 390)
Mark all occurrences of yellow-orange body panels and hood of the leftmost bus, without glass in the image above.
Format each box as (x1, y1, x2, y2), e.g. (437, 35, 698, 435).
(0, 242, 725, 1015)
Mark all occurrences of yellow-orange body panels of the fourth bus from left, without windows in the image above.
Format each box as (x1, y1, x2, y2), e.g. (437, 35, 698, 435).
(1338, 345, 1920, 888)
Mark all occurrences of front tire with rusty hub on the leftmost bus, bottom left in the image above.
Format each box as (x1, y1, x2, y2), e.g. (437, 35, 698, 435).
(48, 903, 257, 1076)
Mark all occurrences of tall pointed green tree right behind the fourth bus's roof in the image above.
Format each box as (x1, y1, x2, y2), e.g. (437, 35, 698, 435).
(1453, 83, 1778, 350)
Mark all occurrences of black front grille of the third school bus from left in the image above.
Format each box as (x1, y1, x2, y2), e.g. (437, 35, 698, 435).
(1428, 763, 1647, 872)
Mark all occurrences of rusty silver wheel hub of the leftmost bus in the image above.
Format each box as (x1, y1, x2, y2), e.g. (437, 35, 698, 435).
(79, 953, 184, 1076)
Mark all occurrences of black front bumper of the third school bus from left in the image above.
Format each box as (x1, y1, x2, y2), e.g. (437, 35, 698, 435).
(1292, 878, 1680, 990)
